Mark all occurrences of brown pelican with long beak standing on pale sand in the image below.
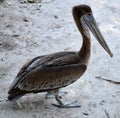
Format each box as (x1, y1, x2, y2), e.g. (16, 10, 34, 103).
(8, 5, 113, 108)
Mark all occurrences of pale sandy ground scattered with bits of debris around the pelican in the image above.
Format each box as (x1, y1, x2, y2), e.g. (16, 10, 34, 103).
(0, 0, 120, 118)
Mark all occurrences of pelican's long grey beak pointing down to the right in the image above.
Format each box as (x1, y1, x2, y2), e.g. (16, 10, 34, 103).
(81, 13, 113, 57)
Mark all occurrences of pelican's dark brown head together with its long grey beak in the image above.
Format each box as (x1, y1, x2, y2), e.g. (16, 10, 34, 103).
(73, 5, 113, 57)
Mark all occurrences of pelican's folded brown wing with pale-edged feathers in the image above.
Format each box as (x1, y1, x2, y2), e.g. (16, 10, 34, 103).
(8, 52, 86, 94)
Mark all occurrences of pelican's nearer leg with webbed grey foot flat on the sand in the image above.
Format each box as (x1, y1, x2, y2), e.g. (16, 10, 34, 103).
(52, 92, 81, 108)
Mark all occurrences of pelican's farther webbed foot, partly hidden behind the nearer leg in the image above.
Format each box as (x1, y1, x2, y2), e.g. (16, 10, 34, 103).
(45, 91, 68, 99)
